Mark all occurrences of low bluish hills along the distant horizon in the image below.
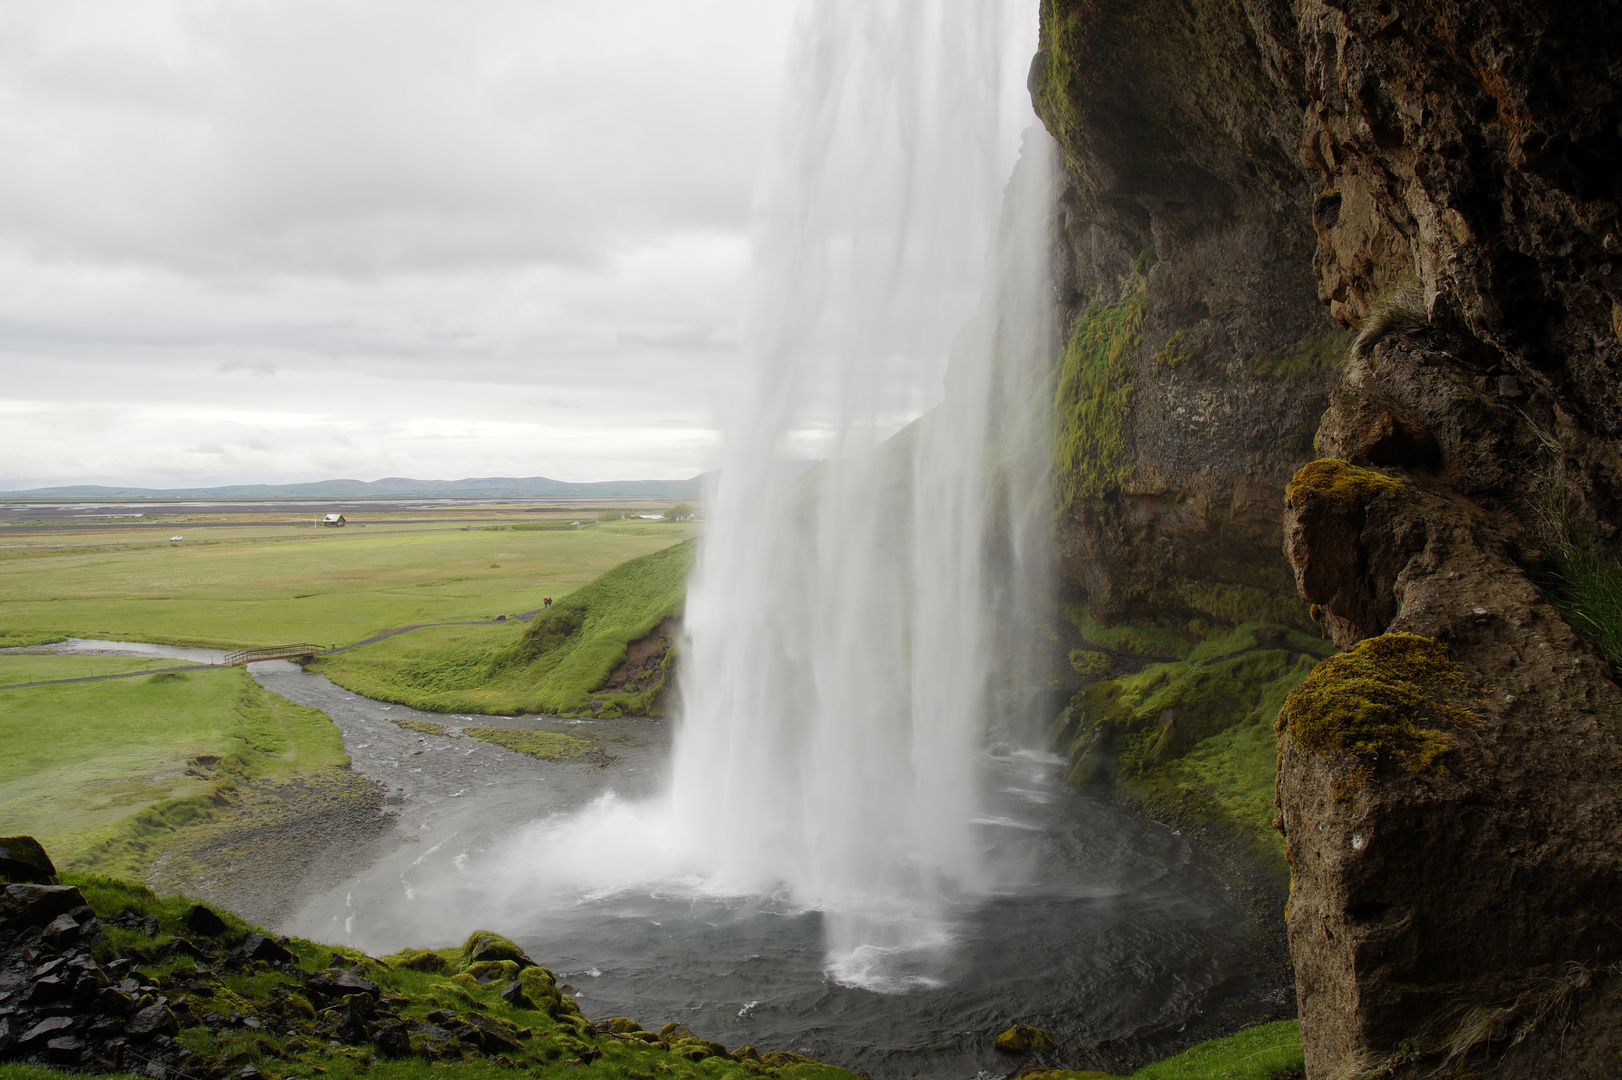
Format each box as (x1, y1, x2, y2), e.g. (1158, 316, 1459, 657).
(0, 475, 704, 499)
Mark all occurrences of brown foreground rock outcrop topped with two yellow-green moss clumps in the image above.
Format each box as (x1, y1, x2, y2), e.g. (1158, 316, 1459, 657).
(1278, 462, 1622, 1077)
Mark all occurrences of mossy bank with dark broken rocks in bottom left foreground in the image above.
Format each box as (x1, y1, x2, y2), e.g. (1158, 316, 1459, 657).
(0, 840, 852, 1080)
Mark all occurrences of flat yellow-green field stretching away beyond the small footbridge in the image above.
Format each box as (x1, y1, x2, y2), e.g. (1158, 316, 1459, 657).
(0, 522, 693, 649)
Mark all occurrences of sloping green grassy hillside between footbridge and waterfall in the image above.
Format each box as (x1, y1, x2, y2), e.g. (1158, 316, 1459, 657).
(315, 540, 694, 715)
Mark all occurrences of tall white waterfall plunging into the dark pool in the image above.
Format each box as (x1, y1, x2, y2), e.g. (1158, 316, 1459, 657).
(668, 0, 1053, 989)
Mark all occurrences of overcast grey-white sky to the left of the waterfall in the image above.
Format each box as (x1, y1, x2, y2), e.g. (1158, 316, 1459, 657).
(0, 0, 798, 490)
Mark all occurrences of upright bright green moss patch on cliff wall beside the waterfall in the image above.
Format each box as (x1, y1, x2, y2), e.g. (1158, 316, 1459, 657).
(1053, 292, 1145, 508)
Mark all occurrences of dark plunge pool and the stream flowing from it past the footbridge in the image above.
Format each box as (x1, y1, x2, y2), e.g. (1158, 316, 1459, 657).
(31, 641, 1289, 1080)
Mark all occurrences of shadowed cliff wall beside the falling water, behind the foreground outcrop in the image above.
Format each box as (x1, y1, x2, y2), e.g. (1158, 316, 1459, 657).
(1030, 2, 1345, 624)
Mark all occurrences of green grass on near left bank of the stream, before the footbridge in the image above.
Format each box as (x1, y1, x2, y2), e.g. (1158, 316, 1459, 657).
(0, 657, 349, 874)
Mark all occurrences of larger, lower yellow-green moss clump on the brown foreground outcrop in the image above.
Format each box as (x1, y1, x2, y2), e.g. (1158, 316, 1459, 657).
(1278, 634, 1481, 772)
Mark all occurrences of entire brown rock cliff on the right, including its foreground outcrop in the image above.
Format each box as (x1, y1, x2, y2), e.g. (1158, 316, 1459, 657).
(1032, 0, 1622, 1077)
